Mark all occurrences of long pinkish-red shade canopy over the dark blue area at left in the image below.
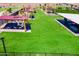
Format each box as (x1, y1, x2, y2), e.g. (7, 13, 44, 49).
(0, 16, 28, 20)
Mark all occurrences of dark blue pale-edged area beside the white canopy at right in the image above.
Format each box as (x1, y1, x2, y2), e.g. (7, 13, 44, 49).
(57, 20, 79, 34)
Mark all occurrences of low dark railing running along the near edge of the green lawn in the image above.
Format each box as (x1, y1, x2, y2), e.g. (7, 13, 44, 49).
(0, 52, 79, 56)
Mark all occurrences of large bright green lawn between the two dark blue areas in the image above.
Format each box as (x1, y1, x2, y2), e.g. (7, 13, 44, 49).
(0, 11, 79, 54)
